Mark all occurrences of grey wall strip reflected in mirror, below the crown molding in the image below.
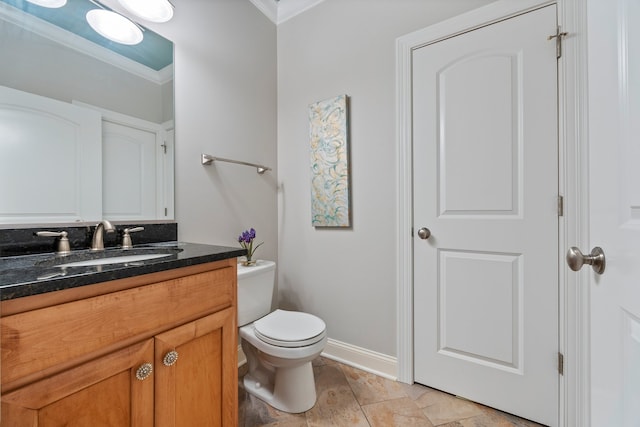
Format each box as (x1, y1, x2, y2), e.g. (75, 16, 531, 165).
(0, 20, 173, 123)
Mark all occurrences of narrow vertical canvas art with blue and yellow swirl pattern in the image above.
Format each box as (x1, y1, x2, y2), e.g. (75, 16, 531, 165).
(309, 95, 351, 227)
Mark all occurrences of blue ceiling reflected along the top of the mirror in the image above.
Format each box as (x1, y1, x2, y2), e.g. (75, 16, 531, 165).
(0, 0, 173, 71)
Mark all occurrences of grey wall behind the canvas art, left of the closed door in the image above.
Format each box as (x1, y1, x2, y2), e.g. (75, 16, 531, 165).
(278, 0, 491, 356)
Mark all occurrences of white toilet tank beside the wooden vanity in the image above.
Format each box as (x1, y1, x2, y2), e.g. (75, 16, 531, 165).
(238, 260, 276, 326)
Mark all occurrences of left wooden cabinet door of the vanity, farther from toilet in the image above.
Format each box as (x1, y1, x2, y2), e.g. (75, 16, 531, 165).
(0, 339, 154, 427)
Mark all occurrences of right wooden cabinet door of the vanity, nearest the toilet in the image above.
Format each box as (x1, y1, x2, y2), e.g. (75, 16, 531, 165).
(155, 308, 238, 427)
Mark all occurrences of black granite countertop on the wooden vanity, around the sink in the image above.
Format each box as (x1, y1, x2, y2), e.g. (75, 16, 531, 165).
(0, 242, 246, 301)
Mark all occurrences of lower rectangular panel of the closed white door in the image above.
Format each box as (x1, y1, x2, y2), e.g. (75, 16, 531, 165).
(438, 250, 522, 370)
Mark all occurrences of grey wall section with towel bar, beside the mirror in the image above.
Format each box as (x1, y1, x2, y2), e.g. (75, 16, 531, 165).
(153, 0, 278, 260)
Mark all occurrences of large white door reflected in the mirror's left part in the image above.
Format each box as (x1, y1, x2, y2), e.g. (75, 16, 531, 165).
(0, 86, 102, 224)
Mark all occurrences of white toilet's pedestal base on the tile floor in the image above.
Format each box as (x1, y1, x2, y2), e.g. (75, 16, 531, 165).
(243, 362, 316, 414)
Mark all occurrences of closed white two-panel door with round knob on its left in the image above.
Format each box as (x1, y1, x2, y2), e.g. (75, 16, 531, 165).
(412, 5, 559, 425)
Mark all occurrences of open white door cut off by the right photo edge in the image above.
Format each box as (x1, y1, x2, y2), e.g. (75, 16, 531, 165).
(576, 0, 640, 427)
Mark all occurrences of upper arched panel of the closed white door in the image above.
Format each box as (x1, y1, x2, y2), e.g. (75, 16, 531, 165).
(436, 52, 522, 215)
